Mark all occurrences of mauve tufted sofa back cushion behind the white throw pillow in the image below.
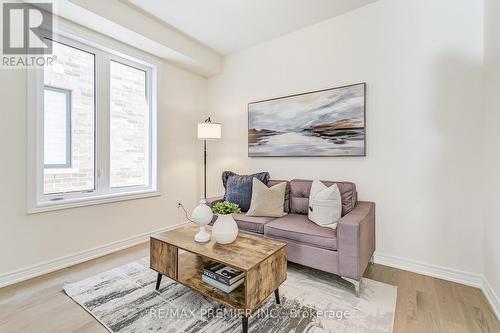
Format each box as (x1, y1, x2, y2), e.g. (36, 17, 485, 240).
(290, 179, 358, 216)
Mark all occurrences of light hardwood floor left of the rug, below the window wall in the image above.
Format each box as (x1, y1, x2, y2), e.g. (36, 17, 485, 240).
(0, 244, 149, 333)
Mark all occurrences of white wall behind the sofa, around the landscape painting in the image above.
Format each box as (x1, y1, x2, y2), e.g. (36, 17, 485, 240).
(209, 0, 484, 274)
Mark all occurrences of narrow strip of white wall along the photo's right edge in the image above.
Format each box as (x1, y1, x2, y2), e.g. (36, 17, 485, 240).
(484, 0, 500, 311)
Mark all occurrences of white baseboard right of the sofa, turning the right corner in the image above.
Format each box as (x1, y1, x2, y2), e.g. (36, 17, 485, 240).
(375, 252, 500, 320)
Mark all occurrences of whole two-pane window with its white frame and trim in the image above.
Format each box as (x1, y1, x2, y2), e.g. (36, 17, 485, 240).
(28, 32, 158, 212)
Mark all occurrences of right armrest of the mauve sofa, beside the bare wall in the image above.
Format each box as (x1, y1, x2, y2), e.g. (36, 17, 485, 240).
(337, 201, 375, 281)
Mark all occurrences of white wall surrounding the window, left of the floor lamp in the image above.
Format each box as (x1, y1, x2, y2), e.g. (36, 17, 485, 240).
(0, 21, 207, 276)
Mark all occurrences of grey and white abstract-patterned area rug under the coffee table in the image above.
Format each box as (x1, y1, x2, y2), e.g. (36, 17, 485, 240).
(64, 257, 396, 333)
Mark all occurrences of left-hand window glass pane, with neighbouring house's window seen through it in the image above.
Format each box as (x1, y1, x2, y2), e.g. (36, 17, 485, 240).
(43, 41, 95, 194)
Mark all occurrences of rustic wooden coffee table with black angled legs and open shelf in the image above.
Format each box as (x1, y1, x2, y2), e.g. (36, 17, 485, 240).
(150, 224, 287, 332)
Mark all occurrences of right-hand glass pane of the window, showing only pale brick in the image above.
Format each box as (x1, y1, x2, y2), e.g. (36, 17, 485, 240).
(110, 61, 150, 187)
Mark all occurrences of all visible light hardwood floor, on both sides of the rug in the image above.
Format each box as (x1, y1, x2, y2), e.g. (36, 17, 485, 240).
(0, 244, 500, 333)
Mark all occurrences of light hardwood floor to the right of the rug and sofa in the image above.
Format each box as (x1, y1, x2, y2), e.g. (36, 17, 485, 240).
(365, 264, 500, 333)
